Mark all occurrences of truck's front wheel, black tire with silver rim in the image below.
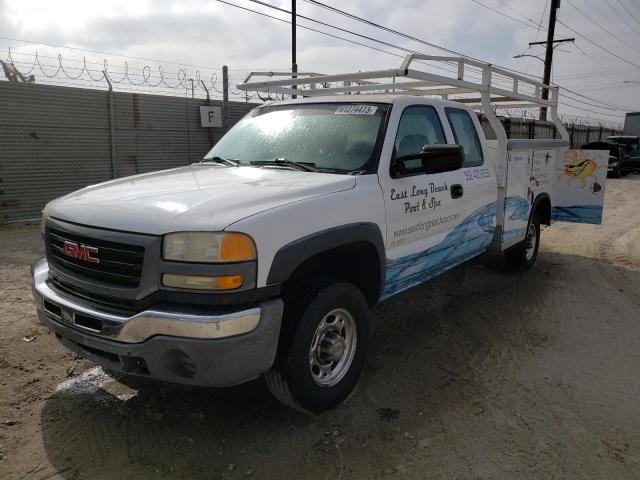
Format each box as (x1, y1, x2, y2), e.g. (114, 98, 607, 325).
(265, 280, 370, 413)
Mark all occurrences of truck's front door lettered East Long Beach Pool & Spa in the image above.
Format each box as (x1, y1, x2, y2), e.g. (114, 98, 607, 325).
(379, 105, 465, 298)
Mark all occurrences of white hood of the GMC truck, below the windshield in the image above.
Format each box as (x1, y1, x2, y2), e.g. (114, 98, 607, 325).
(45, 164, 356, 235)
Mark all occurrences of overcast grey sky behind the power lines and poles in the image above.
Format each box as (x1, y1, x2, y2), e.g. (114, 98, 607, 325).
(0, 0, 640, 122)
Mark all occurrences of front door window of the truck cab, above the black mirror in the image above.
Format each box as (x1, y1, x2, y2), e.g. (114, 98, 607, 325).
(394, 105, 447, 158)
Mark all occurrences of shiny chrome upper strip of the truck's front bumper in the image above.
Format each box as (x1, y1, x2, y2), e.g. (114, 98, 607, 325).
(31, 259, 262, 343)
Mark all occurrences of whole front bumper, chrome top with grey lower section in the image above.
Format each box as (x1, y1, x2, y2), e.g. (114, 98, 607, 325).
(31, 259, 283, 387)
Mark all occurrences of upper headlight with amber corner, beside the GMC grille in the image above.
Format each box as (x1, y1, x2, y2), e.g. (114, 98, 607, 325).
(162, 232, 256, 263)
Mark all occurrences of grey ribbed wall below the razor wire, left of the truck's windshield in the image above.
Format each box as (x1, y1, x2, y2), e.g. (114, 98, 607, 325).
(0, 82, 255, 222)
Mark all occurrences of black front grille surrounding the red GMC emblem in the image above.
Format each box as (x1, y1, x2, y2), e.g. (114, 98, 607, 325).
(46, 228, 144, 288)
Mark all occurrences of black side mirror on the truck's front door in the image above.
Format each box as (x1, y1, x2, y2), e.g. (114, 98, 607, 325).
(390, 145, 464, 178)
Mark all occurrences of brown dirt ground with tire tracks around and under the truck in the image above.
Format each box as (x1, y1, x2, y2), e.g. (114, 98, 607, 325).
(0, 176, 640, 480)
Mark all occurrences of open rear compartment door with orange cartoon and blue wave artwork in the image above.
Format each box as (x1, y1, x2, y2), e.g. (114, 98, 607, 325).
(551, 149, 609, 224)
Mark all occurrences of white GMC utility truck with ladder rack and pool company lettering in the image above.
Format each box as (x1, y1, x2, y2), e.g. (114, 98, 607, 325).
(32, 56, 607, 412)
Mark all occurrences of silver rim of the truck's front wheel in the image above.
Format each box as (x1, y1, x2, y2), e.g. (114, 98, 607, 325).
(309, 308, 358, 387)
